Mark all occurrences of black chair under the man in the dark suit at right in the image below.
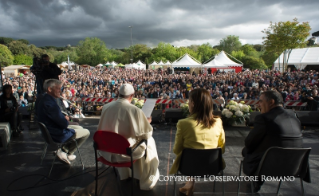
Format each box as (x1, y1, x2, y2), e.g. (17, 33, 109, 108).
(237, 147, 311, 195)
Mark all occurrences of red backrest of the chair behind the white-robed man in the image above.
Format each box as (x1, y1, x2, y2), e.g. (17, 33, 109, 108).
(93, 130, 130, 155)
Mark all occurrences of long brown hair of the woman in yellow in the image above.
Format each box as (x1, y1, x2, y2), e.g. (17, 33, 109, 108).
(189, 88, 216, 128)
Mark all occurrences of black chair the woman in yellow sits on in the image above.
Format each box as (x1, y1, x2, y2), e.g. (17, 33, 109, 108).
(174, 148, 225, 196)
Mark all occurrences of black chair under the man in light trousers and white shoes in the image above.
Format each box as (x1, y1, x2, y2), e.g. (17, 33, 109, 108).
(38, 122, 84, 176)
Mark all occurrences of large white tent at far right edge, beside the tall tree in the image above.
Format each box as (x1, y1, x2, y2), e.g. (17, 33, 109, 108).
(273, 47, 319, 70)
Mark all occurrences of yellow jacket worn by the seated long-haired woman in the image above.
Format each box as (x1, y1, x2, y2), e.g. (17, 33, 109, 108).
(169, 115, 225, 174)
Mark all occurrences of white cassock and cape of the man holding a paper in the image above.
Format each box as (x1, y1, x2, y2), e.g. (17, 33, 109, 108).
(98, 98, 159, 190)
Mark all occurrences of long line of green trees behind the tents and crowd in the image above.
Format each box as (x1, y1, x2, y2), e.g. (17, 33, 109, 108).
(0, 35, 277, 68)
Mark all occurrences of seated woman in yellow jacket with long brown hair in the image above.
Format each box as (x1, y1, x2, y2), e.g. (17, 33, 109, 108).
(170, 89, 225, 195)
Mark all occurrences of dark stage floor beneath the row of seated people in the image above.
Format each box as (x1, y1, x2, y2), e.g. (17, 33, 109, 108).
(0, 118, 319, 196)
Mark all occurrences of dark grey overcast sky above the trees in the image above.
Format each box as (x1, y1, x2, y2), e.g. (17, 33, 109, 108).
(0, 0, 319, 48)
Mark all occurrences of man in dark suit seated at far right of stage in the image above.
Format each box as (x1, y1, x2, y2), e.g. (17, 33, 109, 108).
(242, 91, 302, 192)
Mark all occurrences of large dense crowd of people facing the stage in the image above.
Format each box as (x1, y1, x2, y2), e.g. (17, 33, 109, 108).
(3, 67, 319, 110)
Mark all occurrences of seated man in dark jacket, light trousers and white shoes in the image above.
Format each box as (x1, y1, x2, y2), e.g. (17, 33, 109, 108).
(37, 79, 90, 164)
